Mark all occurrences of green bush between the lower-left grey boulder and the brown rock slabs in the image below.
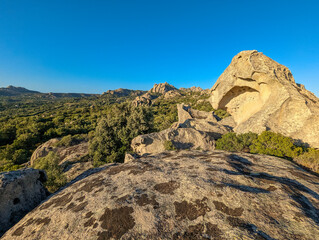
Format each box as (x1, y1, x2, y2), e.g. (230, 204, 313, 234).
(33, 152, 66, 192)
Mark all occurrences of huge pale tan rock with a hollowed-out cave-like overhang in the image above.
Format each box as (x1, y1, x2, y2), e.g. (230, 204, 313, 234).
(211, 51, 319, 147)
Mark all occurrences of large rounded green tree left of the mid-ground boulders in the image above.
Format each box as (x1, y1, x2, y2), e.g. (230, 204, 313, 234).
(89, 103, 152, 166)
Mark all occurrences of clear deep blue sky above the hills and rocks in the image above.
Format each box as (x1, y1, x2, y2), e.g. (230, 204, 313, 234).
(0, 0, 319, 96)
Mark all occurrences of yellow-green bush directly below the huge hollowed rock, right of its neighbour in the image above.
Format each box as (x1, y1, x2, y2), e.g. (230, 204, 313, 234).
(250, 131, 303, 159)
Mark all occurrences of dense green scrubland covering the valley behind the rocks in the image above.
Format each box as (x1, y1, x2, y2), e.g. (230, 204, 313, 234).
(0, 89, 216, 172)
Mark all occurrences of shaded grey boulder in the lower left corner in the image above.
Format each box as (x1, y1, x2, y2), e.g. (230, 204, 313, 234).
(0, 169, 48, 237)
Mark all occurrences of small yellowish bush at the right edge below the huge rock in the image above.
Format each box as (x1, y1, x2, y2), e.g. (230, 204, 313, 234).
(294, 148, 319, 173)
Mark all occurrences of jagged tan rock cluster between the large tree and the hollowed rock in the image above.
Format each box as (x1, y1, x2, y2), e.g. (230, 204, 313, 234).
(131, 104, 231, 154)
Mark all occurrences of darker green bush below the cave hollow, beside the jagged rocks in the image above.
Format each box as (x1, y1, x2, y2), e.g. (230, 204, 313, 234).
(216, 132, 258, 152)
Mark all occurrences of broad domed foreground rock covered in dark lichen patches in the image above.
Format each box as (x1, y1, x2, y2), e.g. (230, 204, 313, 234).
(3, 151, 319, 240)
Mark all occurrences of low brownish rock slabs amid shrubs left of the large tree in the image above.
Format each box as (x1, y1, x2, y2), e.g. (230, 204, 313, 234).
(30, 138, 93, 181)
